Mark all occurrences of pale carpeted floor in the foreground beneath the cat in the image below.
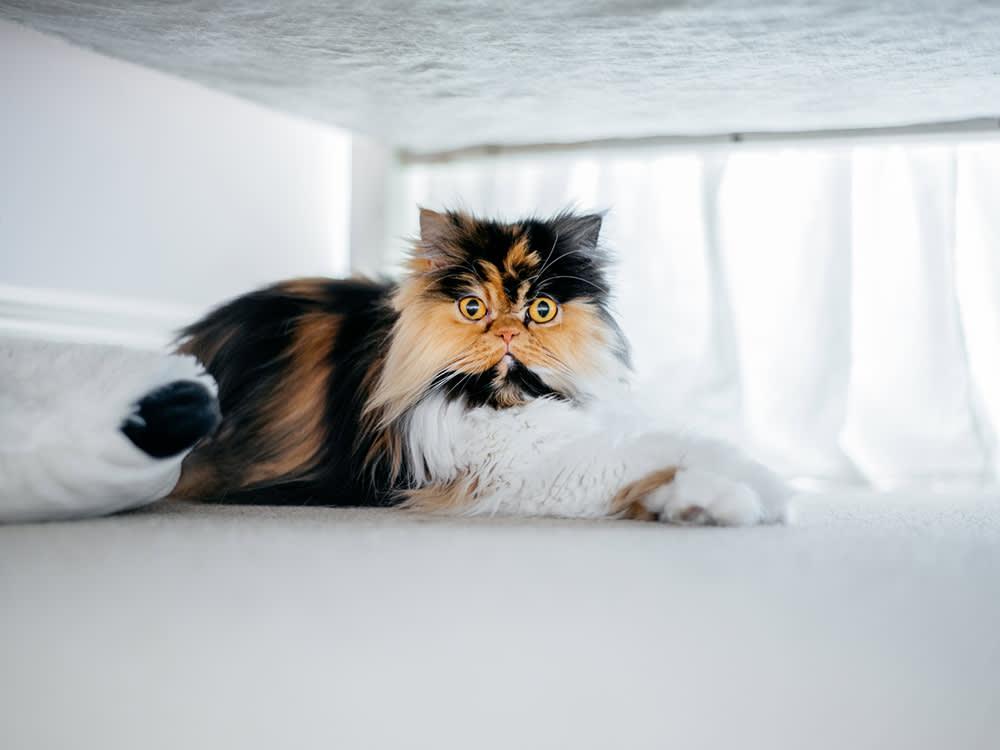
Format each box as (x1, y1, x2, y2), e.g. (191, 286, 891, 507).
(0, 495, 1000, 750)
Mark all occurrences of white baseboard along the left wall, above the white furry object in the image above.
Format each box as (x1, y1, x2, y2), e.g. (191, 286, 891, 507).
(0, 284, 205, 349)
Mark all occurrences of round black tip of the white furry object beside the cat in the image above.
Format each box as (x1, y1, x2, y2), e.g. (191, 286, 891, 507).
(121, 380, 222, 458)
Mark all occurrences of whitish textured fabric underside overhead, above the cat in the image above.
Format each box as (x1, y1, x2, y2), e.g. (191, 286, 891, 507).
(0, 0, 1000, 151)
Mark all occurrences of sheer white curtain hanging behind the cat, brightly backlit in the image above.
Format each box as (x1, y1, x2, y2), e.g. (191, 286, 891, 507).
(392, 142, 1000, 487)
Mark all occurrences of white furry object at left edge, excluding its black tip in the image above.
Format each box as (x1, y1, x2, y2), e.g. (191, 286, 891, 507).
(0, 338, 215, 523)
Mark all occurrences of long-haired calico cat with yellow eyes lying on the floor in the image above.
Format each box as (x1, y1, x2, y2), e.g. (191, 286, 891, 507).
(166, 209, 787, 524)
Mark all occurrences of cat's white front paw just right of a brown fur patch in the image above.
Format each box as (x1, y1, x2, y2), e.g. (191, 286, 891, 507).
(643, 469, 769, 526)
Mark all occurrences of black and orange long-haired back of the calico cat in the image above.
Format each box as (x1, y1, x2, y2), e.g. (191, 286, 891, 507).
(175, 277, 395, 504)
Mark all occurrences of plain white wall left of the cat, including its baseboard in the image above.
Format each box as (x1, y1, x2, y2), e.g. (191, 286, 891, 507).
(0, 22, 351, 340)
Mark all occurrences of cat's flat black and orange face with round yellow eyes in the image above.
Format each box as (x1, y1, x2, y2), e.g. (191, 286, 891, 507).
(372, 209, 627, 420)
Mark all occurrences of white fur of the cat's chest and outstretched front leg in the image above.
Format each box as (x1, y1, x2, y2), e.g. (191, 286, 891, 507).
(407, 396, 787, 522)
